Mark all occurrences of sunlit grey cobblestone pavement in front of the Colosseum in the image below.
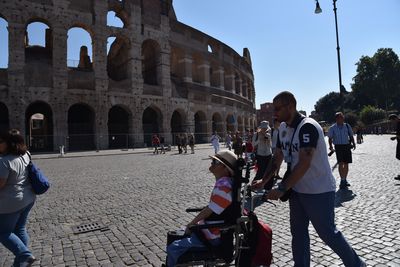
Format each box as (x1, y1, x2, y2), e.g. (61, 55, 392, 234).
(0, 136, 400, 267)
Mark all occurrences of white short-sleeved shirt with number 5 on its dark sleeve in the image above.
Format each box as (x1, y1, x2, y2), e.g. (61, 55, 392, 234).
(277, 114, 336, 194)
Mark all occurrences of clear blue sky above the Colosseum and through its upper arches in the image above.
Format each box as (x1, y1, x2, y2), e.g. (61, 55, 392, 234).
(0, 0, 400, 114)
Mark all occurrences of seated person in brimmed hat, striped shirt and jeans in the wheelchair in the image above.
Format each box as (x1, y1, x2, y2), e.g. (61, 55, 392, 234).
(167, 151, 237, 267)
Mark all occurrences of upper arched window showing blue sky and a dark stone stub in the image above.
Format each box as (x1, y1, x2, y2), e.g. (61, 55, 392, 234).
(67, 27, 93, 70)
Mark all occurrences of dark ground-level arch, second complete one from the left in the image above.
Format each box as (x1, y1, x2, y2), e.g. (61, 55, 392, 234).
(68, 103, 95, 151)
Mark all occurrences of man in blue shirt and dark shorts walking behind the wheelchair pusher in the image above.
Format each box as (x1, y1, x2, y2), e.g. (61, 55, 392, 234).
(328, 112, 356, 189)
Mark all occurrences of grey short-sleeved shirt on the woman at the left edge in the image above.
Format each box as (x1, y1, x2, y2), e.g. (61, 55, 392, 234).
(0, 154, 36, 214)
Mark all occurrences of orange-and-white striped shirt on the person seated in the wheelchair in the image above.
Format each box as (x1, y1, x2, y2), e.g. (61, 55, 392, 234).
(201, 177, 233, 240)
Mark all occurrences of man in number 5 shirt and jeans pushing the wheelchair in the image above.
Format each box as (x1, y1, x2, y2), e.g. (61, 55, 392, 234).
(253, 91, 366, 267)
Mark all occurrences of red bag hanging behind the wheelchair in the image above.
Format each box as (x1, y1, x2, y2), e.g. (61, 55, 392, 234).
(251, 221, 272, 266)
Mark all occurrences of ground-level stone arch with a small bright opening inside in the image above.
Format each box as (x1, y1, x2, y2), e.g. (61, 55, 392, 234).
(25, 101, 54, 152)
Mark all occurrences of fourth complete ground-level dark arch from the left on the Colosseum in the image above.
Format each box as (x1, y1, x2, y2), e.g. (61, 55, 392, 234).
(142, 105, 163, 146)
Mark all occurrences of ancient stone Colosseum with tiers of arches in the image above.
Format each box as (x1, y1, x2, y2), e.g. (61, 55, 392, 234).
(0, 0, 256, 152)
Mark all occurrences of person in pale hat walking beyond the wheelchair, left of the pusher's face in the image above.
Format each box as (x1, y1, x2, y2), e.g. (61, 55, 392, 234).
(252, 121, 274, 190)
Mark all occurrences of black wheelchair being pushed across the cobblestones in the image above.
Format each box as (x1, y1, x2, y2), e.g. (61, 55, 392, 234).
(162, 158, 272, 267)
